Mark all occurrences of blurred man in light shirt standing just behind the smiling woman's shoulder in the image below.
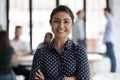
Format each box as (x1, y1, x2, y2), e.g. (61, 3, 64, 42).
(72, 10, 86, 48)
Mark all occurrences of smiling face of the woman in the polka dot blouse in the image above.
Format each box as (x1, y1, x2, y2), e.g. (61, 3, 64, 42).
(51, 12, 72, 38)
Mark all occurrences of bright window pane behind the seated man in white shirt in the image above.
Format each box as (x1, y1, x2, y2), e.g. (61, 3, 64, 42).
(9, 0, 30, 42)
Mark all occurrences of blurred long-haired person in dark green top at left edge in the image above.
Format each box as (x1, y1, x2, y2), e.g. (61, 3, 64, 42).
(0, 31, 16, 80)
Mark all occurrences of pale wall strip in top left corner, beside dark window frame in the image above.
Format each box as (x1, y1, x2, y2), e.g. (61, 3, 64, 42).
(0, 0, 7, 30)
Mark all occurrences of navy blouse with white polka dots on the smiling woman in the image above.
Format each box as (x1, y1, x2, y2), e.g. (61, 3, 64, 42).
(30, 40, 90, 80)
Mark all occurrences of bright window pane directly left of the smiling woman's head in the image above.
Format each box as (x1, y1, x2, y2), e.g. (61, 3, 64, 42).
(32, 0, 56, 50)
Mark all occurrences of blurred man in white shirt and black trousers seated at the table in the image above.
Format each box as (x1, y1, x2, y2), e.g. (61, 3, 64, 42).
(11, 26, 30, 80)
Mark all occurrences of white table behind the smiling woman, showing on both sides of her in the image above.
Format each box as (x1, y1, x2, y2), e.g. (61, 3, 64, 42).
(14, 54, 103, 80)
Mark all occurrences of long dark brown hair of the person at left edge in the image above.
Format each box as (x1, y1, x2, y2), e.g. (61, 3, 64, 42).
(0, 31, 10, 54)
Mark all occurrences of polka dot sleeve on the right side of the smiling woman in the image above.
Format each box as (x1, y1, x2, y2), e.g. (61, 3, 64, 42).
(76, 46, 90, 80)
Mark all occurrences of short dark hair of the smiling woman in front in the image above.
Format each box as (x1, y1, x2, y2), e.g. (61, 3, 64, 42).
(50, 5, 74, 24)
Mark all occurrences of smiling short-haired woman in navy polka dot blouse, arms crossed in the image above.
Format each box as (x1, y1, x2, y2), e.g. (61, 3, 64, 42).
(30, 5, 90, 80)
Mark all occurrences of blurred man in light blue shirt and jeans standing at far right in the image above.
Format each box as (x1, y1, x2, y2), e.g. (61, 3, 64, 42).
(103, 8, 116, 72)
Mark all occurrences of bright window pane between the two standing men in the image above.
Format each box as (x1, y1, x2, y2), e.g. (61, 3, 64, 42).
(86, 0, 106, 52)
